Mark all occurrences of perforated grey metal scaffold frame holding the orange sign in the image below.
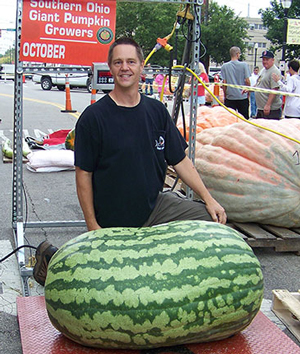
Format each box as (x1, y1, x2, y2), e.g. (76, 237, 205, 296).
(12, 0, 203, 296)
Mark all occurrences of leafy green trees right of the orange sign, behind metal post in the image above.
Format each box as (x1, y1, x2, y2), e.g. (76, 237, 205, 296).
(116, 2, 248, 67)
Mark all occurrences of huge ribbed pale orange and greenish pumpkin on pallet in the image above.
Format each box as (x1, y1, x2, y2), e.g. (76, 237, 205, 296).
(195, 119, 300, 228)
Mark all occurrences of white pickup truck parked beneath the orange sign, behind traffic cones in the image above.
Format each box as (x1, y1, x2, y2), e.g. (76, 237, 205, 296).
(32, 66, 92, 92)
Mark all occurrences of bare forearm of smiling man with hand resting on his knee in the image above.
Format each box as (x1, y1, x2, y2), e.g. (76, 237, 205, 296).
(173, 156, 227, 224)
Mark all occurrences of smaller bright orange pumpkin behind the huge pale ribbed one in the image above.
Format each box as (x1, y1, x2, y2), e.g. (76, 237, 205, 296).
(177, 106, 239, 141)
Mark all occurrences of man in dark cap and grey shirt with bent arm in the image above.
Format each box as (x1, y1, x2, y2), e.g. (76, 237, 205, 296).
(255, 50, 282, 119)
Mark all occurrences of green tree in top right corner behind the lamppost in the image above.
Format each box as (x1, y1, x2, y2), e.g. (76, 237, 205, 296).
(259, 0, 300, 60)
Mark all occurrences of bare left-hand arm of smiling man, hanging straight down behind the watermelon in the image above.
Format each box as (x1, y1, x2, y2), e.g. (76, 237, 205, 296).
(75, 166, 101, 231)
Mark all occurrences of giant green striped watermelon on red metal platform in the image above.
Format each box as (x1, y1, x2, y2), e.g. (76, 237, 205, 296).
(45, 221, 263, 349)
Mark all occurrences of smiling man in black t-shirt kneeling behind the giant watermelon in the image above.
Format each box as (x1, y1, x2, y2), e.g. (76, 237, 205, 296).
(34, 38, 226, 285)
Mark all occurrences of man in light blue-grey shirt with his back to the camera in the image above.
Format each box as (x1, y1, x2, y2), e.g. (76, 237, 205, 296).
(221, 47, 250, 119)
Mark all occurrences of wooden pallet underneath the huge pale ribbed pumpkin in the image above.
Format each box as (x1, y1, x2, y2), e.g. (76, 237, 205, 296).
(165, 168, 300, 255)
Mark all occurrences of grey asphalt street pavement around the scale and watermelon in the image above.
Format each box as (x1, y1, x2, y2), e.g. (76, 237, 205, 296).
(0, 80, 300, 354)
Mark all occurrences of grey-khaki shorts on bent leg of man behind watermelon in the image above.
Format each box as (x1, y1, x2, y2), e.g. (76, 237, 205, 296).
(143, 191, 212, 226)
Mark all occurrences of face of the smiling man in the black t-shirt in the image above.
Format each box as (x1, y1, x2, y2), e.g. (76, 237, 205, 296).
(110, 44, 144, 88)
